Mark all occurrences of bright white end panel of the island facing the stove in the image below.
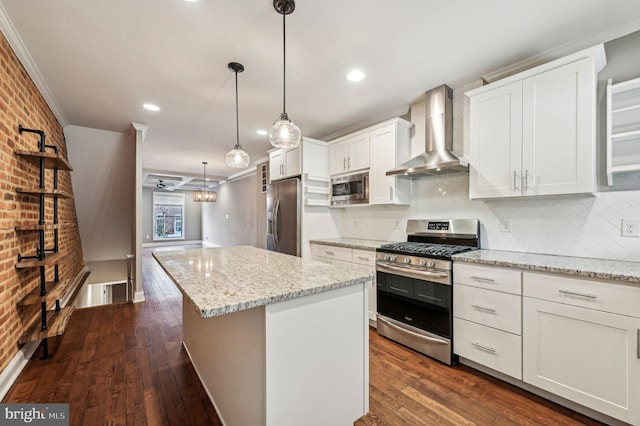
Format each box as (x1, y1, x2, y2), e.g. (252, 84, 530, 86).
(265, 284, 369, 426)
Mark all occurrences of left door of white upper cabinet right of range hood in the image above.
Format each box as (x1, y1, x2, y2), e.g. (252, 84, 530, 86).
(469, 82, 522, 199)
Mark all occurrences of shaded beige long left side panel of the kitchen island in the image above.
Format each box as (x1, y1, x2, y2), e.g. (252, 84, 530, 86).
(182, 297, 266, 426)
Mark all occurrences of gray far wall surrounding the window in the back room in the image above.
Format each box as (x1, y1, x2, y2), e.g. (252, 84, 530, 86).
(142, 188, 201, 245)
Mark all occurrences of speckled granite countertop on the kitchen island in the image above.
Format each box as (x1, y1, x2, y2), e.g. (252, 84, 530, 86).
(153, 246, 371, 318)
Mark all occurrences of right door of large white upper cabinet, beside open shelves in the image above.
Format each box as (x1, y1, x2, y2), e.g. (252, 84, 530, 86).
(522, 58, 596, 195)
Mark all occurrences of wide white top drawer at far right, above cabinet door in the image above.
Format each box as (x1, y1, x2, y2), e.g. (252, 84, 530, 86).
(523, 272, 640, 318)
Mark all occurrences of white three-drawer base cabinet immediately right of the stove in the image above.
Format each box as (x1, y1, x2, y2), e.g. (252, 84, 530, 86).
(453, 263, 522, 379)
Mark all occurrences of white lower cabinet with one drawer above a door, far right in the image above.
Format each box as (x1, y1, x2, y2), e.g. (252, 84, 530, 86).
(523, 272, 640, 425)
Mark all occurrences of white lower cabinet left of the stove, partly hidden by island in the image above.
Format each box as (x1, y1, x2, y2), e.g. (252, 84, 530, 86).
(311, 243, 377, 327)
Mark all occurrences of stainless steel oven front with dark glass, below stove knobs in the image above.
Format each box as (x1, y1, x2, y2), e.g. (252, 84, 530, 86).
(376, 271, 454, 365)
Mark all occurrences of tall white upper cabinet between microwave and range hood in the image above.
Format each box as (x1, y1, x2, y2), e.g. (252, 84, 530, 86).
(369, 119, 411, 205)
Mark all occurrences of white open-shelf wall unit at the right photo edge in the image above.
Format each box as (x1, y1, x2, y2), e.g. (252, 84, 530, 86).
(607, 78, 640, 186)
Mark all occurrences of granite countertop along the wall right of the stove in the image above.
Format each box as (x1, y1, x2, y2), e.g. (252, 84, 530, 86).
(453, 250, 640, 287)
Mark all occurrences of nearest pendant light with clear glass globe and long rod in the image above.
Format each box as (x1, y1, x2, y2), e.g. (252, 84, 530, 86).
(269, 0, 302, 148)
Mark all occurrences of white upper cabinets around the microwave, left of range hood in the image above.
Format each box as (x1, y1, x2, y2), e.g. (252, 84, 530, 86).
(329, 118, 412, 205)
